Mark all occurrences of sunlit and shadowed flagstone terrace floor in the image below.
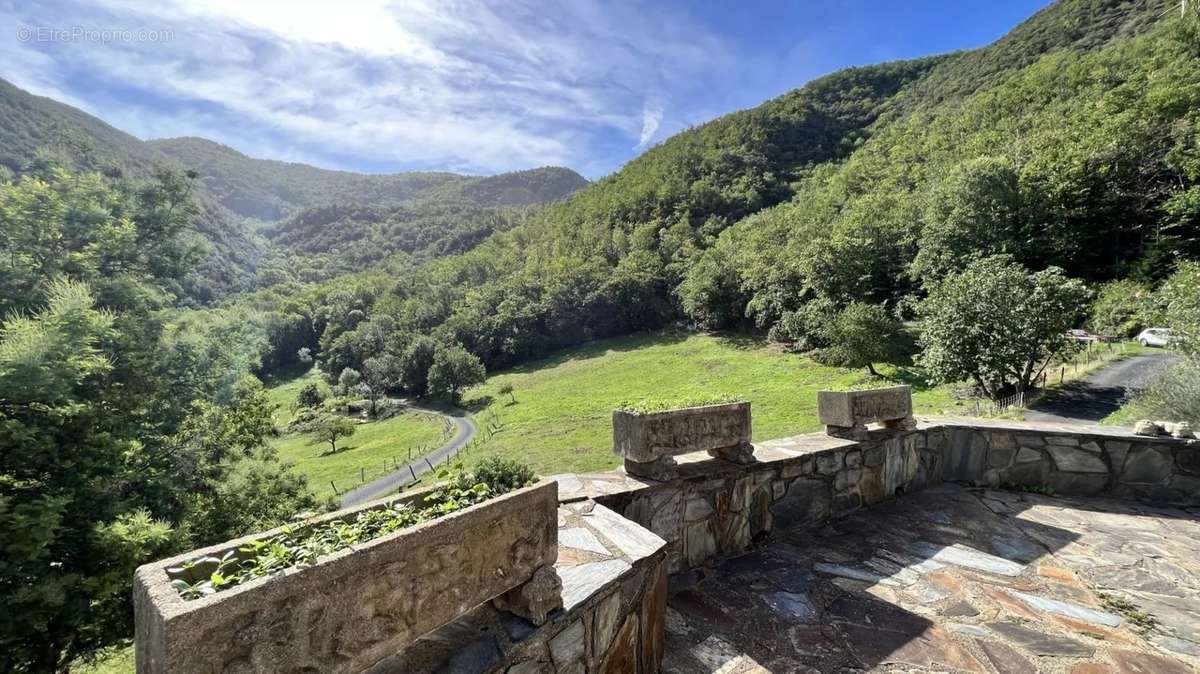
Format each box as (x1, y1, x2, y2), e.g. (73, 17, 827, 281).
(662, 486, 1200, 674)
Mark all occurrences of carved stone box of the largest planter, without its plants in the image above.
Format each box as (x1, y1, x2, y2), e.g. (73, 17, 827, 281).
(133, 481, 562, 674)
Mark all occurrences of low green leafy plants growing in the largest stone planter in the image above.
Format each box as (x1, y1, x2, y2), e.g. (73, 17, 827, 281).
(167, 457, 536, 600)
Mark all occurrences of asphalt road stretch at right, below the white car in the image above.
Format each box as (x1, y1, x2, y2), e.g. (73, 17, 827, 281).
(1025, 351, 1175, 423)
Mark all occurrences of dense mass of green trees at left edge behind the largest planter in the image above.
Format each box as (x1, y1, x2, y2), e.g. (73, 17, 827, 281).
(0, 164, 314, 672)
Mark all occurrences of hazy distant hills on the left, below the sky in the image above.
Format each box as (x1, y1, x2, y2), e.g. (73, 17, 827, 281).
(0, 79, 587, 302)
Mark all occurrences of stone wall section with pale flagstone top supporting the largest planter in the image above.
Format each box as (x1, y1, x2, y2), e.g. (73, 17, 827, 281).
(368, 501, 667, 674)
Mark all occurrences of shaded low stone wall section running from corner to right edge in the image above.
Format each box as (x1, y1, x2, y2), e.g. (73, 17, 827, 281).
(930, 425, 1200, 505)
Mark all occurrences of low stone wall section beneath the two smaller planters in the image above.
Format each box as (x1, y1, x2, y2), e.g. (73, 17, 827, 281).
(588, 431, 942, 572)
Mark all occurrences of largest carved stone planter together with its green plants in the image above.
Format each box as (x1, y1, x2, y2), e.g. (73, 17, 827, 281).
(134, 461, 562, 673)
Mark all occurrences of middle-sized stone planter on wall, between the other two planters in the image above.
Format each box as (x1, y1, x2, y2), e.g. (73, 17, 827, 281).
(612, 402, 754, 480)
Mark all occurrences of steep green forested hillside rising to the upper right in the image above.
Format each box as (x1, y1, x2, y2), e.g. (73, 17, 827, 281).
(292, 0, 1200, 388)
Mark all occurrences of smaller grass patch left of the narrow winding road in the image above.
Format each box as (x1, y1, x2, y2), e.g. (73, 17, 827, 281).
(268, 362, 445, 498)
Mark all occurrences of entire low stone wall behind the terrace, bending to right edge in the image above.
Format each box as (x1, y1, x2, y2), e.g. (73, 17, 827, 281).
(557, 419, 1200, 573)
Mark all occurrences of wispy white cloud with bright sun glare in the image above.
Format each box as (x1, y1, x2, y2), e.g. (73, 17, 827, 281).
(0, 0, 730, 175)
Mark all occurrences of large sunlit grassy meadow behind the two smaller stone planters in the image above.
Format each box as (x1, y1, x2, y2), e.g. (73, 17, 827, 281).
(463, 335, 954, 474)
